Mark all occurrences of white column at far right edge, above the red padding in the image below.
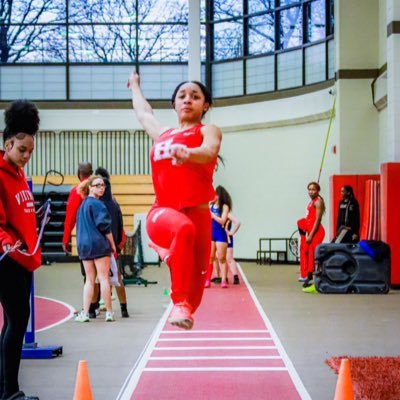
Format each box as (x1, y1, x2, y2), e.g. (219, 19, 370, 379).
(382, 0, 400, 162)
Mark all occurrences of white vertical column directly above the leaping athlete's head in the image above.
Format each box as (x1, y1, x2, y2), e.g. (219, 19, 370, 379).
(188, 0, 201, 81)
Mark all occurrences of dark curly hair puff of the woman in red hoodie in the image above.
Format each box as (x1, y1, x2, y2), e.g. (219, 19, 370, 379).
(3, 100, 40, 142)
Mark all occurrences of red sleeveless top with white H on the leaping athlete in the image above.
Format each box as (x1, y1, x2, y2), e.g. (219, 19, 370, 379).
(150, 124, 217, 210)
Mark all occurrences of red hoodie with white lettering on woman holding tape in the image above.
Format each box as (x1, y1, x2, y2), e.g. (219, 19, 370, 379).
(0, 151, 42, 271)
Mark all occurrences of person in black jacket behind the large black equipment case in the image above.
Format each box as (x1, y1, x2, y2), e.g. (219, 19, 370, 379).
(335, 185, 360, 243)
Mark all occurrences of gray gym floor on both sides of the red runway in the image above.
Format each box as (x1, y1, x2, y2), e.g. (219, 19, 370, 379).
(20, 263, 400, 400)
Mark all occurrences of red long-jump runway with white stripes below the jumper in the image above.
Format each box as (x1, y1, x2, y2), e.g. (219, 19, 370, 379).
(118, 266, 310, 400)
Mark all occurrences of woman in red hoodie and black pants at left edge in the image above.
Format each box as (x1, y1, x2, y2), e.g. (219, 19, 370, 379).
(0, 100, 41, 400)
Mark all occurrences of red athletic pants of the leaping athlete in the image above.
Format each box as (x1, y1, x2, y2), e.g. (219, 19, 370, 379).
(146, 207, 211, 312)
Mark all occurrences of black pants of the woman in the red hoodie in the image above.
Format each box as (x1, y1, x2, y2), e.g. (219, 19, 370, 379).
(0, 257, 32, 398)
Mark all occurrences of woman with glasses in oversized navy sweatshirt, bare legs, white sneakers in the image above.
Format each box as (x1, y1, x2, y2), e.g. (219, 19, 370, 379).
(75, 175, 117, 322)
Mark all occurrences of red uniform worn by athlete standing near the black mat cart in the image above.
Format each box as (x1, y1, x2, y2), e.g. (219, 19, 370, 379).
(300, 197, 325, 277)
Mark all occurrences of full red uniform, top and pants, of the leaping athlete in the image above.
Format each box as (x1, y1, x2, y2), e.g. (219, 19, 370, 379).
(146, 124, 217, 312)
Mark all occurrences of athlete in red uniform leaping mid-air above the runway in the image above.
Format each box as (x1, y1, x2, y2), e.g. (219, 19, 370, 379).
(128, 73, 222, 329)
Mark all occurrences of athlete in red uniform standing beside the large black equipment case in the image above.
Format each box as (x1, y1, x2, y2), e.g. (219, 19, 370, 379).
(300, 182, 325, 289)
